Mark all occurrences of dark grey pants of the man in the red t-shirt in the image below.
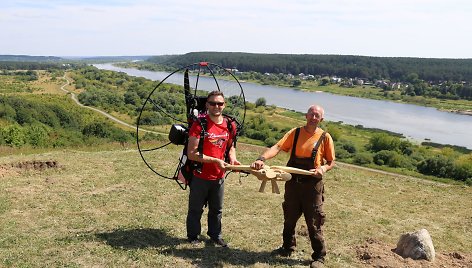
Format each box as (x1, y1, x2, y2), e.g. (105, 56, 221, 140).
(187, 176, 224, 239)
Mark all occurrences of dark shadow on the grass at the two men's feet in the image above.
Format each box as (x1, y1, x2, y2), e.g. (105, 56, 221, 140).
(95, 228, 308, 267)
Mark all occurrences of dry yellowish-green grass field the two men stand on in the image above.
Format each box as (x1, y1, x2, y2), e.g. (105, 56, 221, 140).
(0, 144, 472, 267)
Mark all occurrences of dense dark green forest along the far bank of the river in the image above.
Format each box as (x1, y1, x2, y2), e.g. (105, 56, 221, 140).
(148, 52, 472, 82)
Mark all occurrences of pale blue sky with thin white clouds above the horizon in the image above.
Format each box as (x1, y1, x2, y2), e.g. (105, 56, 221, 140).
(0, 0, 472, 58)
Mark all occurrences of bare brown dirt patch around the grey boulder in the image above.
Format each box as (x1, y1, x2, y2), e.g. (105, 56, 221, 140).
(356, 239, 472, 268)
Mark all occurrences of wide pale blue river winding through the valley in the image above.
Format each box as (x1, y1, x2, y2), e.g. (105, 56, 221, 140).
(94, 64, 472, 149)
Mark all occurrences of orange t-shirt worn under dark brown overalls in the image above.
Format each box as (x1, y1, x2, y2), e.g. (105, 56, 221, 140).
(277, 127, 335, 167)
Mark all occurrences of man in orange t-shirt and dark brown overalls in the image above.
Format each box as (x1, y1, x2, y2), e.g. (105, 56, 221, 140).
(251, 105, 335, 267)
